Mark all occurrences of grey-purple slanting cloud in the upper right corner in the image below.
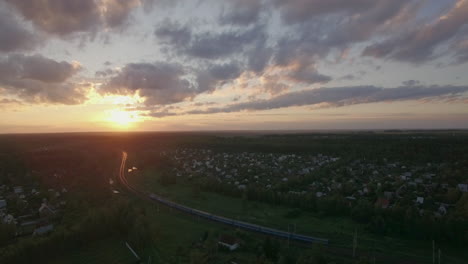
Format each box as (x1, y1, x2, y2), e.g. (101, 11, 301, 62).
(363, 0, 468, 63)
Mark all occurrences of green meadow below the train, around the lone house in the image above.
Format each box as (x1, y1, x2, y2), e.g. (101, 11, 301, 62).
(127, 194, 353, 264)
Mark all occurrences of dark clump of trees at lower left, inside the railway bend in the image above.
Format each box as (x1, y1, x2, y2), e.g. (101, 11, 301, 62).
(0, 198, 158, 264)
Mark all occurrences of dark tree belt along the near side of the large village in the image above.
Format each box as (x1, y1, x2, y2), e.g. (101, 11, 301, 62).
(199, 175, 468, 245)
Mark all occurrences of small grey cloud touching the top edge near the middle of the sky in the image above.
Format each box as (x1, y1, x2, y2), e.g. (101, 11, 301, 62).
(219, 0, 262, 26)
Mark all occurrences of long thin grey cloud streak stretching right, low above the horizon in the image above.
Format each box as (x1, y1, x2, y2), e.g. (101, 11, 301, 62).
(149, 86, 468, 116)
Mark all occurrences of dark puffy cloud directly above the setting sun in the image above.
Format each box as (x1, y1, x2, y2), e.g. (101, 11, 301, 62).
(101, 62, 195, 105)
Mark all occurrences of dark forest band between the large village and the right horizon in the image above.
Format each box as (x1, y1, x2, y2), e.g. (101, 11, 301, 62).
(192, 133, 468, 163)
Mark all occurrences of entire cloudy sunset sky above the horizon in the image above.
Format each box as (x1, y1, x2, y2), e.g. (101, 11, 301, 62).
(0, 0, 468, 133)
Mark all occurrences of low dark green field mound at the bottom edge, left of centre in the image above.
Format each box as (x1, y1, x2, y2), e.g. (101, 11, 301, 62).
(50, 238, 136, 264)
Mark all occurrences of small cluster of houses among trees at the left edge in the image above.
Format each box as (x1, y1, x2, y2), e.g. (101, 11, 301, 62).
(0, 172, 68, 239)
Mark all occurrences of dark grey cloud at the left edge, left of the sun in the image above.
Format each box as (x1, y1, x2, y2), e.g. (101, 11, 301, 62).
(0, 54, 86, 104)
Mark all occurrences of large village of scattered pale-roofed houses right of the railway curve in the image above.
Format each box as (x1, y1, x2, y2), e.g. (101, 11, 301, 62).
(165, 149, 468, 217)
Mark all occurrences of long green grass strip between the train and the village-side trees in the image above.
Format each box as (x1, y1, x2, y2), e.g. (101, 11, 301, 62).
(128, 171, 468, 263)
